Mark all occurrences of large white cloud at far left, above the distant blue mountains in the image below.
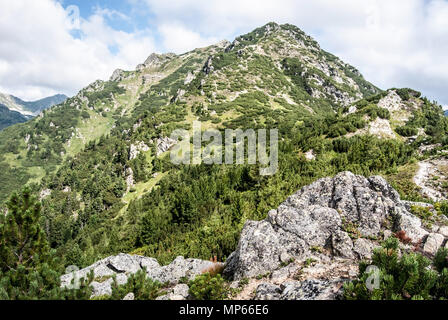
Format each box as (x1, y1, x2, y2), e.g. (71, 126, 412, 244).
(0, 0, 154, 99)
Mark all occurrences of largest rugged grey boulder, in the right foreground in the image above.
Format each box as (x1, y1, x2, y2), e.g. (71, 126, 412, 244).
(224, 172, 430, 279)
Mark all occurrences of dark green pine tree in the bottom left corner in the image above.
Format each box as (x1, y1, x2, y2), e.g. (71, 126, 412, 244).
(0, 188, 90, 300)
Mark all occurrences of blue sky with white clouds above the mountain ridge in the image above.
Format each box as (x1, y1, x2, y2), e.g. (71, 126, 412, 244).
(0, 0, 448, 108)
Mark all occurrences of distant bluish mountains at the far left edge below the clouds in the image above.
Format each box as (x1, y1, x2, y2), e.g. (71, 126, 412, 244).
(0, 93, 68, 130)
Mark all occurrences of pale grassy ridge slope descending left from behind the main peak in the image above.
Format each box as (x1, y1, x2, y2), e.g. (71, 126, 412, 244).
(0, 40, 226, 201)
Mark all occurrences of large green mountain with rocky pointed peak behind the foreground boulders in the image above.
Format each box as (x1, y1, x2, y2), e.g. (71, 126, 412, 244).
(0, 23, 448, 266)
